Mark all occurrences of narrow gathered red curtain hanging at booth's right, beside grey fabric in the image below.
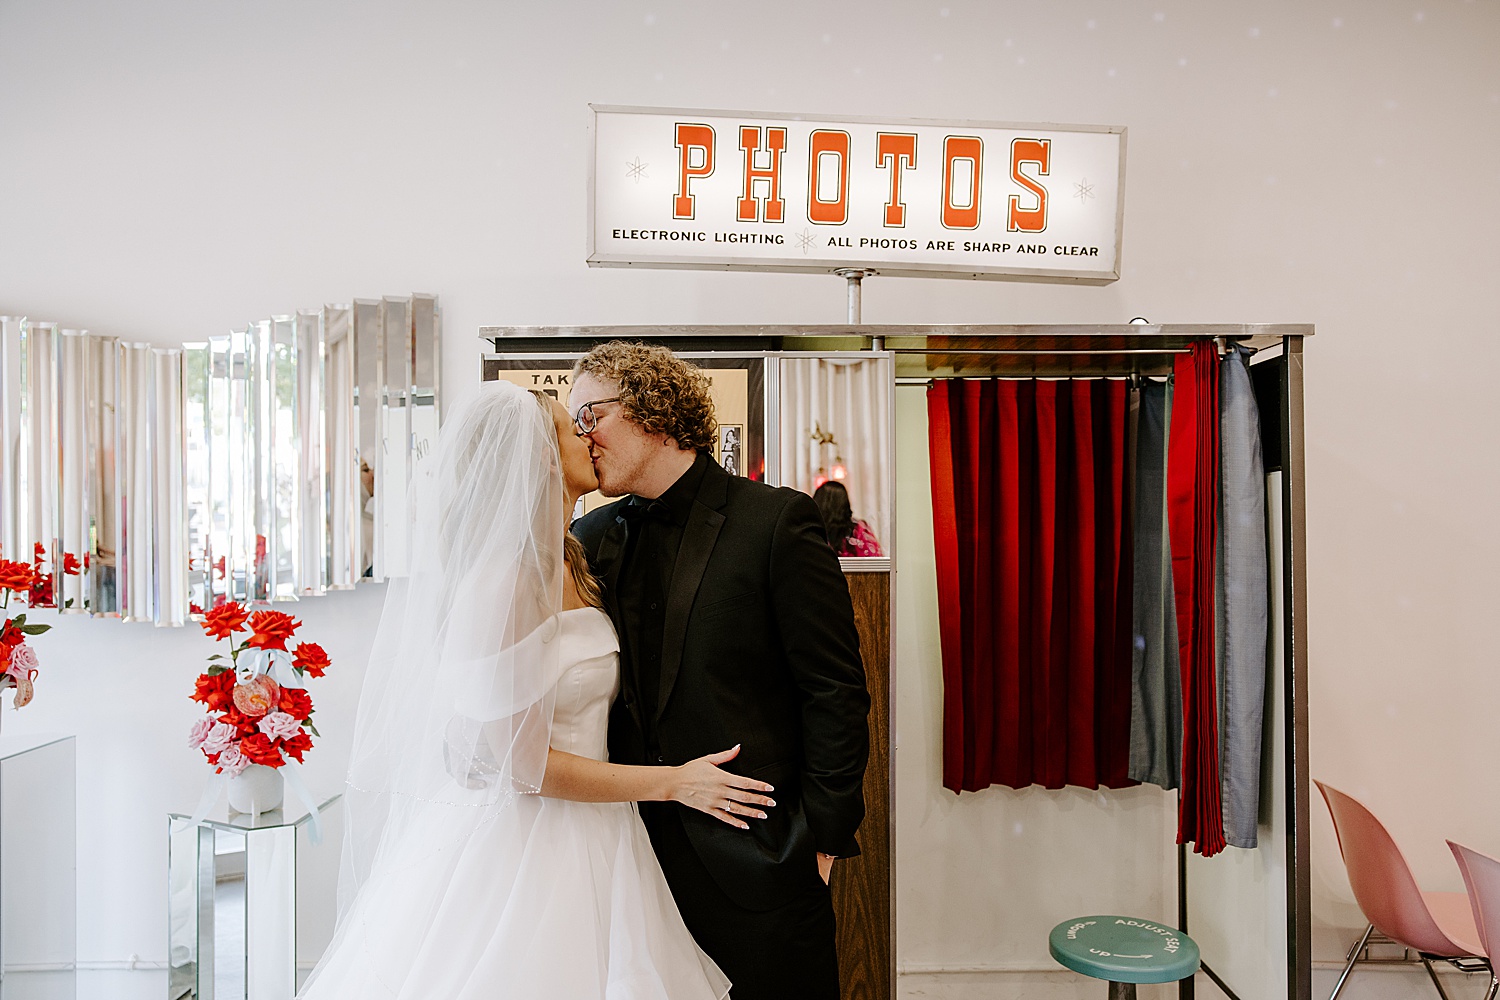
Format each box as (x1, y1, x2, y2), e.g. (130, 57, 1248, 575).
(1167, 347, 1224, 858)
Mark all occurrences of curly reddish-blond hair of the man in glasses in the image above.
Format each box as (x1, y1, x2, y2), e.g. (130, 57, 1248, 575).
(573, 340, 719, 451)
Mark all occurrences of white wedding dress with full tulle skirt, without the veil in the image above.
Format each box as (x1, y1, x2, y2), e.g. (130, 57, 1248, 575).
(300, 607, 729, 1000)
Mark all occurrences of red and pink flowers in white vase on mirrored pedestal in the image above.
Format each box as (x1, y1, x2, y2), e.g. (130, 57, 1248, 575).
(188, 603, 329, 777)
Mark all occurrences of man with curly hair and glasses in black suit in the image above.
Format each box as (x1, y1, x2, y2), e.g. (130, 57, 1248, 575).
(570, 340, 870, 1000)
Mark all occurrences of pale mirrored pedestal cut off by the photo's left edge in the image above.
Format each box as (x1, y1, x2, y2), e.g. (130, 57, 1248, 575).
(0, 735, 78, 1000)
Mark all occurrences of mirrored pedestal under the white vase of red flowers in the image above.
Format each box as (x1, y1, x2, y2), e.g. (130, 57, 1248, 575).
(167, 795, 342, 1000)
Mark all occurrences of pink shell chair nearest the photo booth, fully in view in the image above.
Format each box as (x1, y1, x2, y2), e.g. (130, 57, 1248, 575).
(1314, 781, 1488, 1000)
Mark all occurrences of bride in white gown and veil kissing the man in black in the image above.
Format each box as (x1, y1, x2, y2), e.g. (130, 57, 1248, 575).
(299, 382, 773, 1000)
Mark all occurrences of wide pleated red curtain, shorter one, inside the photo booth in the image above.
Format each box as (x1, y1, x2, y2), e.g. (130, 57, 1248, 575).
(927, 379, 1131, 792)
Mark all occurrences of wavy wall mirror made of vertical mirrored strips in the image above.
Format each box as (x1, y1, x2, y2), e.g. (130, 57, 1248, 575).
(0, 295, 441, 625)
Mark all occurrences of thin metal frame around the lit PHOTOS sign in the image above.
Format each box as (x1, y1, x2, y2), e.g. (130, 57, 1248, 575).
(587, 102, 1127, 285)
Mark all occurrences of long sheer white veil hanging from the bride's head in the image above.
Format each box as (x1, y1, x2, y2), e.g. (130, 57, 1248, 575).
(309, 382, 564, 985)
